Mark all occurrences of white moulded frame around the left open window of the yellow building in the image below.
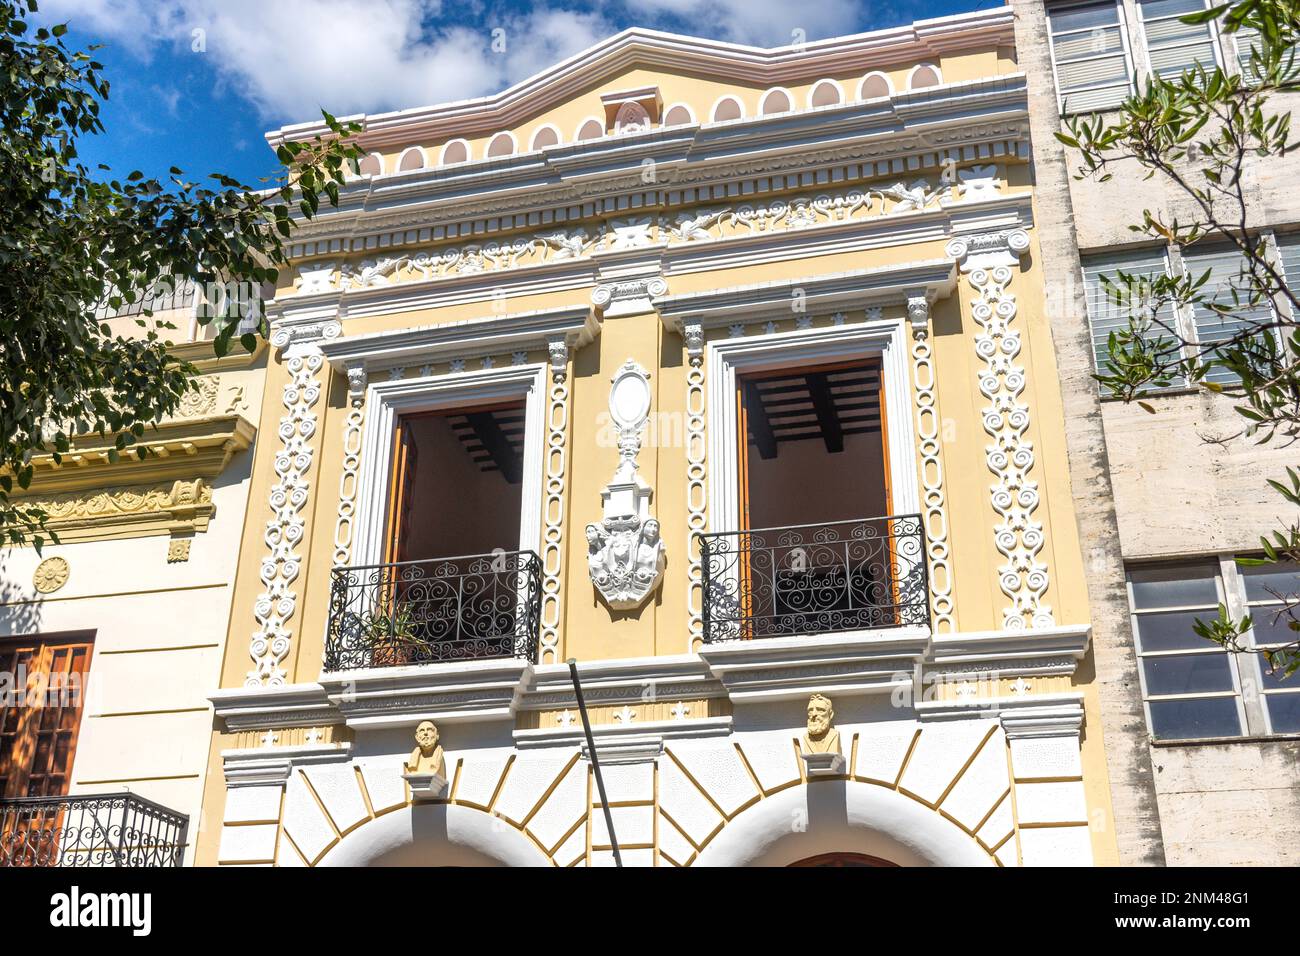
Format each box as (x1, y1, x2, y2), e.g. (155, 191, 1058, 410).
(351, 359, 547, 566)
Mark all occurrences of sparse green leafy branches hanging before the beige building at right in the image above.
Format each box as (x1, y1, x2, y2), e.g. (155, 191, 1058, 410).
(1057, 0, 1300, 675)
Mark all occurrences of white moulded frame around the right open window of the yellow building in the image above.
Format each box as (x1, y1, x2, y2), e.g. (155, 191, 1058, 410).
(705, 317, 920, 532)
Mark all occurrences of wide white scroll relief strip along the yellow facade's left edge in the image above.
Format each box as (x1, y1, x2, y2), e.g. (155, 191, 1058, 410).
(244, 348, 327, 687)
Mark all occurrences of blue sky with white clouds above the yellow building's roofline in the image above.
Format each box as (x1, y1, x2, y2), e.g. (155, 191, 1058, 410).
(38, 0, 1000, 185)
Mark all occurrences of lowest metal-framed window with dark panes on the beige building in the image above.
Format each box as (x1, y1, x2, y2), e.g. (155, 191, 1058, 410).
(1128, 555, 1300, 740)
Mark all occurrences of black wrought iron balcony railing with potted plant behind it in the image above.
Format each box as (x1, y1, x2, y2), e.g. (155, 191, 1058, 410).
(325, 551, 542, 671)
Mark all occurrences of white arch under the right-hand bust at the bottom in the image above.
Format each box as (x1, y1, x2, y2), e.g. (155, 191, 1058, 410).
(694, 780, 995, 866)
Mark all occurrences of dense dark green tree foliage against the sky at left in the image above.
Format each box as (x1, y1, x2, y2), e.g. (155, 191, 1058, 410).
(0, 0, 359, 549)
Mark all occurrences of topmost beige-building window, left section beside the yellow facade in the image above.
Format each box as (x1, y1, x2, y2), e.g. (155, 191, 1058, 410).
(1048, 0, 1132, 113)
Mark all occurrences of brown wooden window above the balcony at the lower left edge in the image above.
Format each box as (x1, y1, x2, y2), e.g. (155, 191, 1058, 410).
(0, 635, 91, 799)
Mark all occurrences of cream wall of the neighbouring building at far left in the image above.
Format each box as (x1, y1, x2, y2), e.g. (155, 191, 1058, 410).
(0, 359, 264, 861)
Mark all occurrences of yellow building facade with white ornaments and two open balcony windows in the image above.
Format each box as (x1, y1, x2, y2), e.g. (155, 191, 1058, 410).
(195, 9, 1117, 866)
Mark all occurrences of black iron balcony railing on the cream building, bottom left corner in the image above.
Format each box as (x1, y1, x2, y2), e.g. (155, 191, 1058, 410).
(0, 793, 190, 866)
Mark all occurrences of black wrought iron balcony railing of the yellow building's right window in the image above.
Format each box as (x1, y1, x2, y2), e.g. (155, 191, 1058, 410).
(699, 515, 930, 643)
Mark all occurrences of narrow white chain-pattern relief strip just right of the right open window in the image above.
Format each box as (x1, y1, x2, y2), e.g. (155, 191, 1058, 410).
(907, 293, 956, 633)
